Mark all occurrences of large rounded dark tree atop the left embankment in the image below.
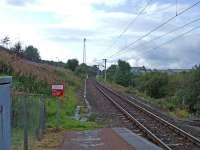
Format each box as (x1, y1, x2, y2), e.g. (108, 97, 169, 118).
(24, 45, 40, 62)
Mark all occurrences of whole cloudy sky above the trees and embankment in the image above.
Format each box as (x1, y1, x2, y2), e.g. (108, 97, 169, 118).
(0, 0, 200, 68)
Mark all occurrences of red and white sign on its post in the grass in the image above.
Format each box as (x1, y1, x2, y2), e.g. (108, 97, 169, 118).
(51, 84, 64, 128)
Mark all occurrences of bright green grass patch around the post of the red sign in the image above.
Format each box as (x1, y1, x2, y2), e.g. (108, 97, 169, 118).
(47, 87, 100, 130)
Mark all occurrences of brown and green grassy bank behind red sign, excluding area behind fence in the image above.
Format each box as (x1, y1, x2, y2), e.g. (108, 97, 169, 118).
(0, 47, 97, 129)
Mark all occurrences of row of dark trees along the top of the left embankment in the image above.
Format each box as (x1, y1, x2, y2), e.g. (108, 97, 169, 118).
(0, 36, 97, 78)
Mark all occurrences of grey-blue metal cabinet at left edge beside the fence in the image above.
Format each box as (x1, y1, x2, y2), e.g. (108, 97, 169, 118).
(0, 77, 12, 150)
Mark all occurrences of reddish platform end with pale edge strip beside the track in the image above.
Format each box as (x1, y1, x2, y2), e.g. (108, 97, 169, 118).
(60, 128, 161, 150)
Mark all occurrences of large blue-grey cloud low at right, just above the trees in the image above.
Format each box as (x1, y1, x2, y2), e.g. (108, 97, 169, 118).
(115, 34, 200, 68)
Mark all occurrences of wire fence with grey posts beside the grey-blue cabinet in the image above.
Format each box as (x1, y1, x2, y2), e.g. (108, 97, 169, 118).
(11, 94, 45, 150)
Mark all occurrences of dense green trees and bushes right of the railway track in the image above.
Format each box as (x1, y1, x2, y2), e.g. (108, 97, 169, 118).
(107, 60, 200, 115)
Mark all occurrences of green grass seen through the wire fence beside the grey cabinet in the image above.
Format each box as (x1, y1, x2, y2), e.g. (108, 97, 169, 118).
(11, 95, 40, 150)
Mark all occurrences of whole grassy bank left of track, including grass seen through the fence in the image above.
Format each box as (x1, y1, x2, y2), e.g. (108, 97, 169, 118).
(0, 48, 97, 150)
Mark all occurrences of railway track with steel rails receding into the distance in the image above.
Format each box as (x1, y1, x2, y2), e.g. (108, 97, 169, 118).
(95, 82, 200, 150)
